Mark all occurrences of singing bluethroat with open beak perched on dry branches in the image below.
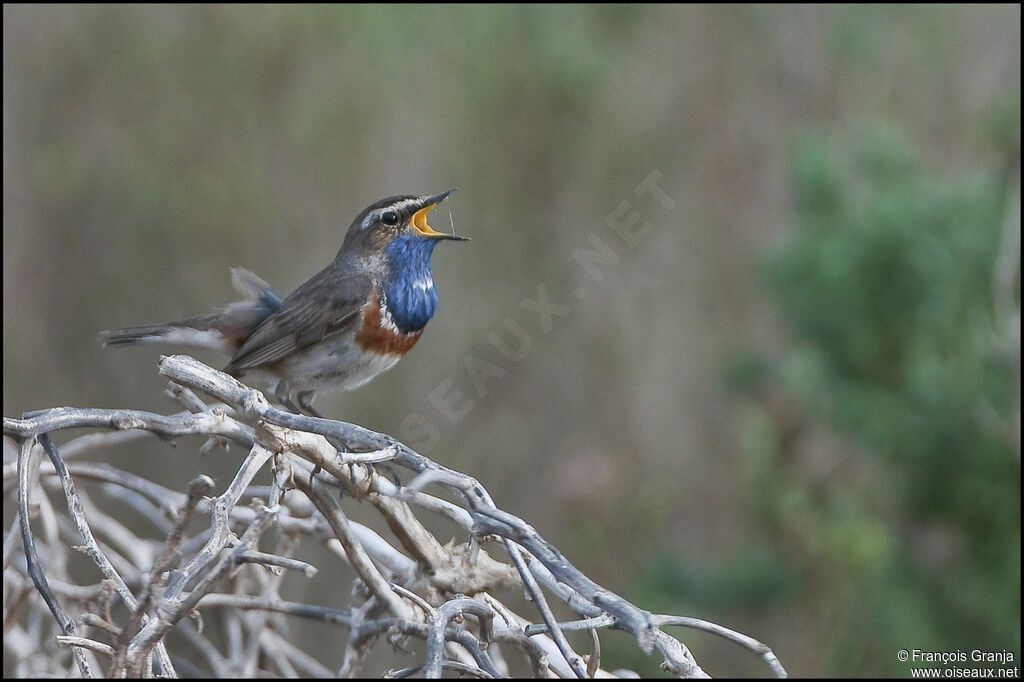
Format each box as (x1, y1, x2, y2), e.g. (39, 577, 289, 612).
(99, 189, 467, 417)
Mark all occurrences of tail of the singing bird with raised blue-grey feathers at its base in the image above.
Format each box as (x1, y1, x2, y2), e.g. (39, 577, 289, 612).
(99, 267, 282, 355)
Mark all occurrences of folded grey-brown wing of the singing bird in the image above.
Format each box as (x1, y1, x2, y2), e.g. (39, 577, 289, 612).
(224, 263, 373, 374)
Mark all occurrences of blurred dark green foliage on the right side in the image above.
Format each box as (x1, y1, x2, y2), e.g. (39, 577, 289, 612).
(733, 123, 1021, 675)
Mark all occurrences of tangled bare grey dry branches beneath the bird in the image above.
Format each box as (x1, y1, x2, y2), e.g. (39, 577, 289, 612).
(3, 355, 785, 678)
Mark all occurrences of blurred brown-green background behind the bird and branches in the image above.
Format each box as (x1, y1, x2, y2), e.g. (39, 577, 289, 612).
(3, 5, 1021, 676)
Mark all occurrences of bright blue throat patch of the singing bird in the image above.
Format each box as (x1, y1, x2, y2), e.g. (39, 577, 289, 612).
(384, 235, 437, 334)
